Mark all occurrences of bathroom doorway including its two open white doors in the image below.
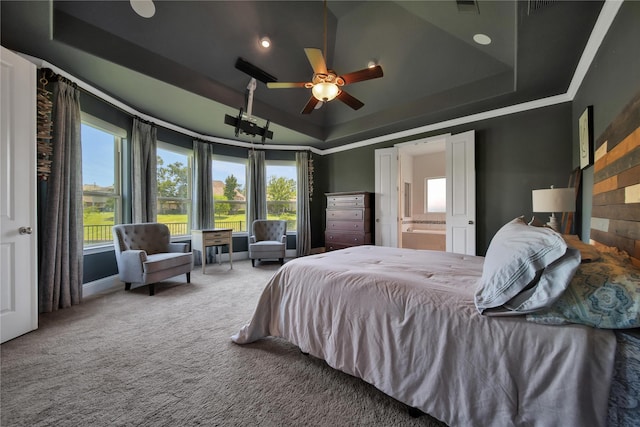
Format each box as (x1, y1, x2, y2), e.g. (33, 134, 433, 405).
(375, 131, 475, 255)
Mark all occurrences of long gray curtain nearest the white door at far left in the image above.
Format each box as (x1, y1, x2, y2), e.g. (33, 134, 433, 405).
(38, 81, 84, 313)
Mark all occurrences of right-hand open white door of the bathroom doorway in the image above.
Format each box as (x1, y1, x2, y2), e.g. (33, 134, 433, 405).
(446, 131, 476, 255)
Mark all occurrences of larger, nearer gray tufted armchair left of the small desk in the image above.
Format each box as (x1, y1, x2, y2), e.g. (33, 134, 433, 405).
(113, 222, 193, 295)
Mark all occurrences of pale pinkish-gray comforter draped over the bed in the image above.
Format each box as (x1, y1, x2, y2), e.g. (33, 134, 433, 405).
(232, 246, 615, 427)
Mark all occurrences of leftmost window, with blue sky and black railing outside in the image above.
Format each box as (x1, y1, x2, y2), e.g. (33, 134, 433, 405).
(80, 113, 126, 248)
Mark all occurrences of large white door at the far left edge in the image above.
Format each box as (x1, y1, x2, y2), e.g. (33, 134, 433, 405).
(0, 47, 38, 342)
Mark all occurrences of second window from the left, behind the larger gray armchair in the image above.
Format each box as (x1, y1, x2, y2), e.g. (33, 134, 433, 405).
(156, 141, 193, 236)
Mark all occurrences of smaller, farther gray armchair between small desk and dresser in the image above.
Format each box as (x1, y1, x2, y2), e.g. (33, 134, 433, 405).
(249, 219, 287, 267)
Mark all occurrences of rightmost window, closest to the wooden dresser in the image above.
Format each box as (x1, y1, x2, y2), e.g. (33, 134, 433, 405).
(267, 160, 298, 231)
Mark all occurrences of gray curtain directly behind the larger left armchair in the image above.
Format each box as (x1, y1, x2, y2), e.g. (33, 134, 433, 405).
(131, 117, 158, 223)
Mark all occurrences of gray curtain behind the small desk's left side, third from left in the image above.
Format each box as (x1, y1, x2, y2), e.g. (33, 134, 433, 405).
(191, 141, 215, 265)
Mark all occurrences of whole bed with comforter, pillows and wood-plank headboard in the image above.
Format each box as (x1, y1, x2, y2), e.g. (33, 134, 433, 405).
(232, 93, 640, 427)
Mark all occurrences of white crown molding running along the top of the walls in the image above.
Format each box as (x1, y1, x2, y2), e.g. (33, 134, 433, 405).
(18, 0, 624, 155)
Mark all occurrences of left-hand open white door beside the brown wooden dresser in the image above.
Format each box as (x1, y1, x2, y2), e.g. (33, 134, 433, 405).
(374, 147, 398, 248)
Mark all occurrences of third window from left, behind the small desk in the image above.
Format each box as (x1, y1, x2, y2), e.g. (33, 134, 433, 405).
(211, 155, 247, 232)
